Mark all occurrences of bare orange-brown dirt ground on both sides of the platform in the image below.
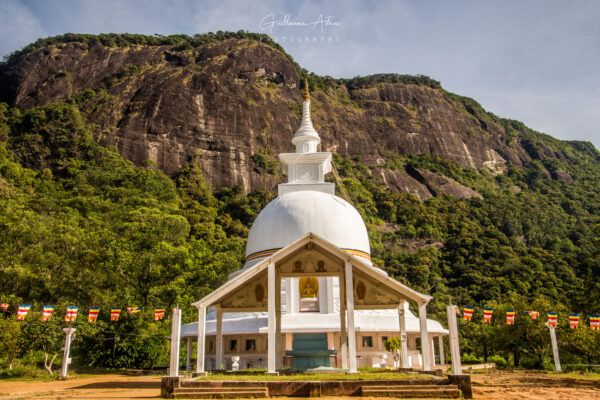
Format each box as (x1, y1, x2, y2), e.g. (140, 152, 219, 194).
(0, 371, 600, 400)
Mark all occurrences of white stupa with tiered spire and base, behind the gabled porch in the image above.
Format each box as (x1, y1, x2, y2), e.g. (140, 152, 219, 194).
(181, 81, 448, 369)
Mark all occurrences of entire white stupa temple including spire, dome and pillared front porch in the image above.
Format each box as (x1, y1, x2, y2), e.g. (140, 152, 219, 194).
(181, 83, 448, 372)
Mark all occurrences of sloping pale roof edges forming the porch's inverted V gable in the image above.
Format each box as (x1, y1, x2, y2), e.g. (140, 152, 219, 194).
(192, 233, 432, 307)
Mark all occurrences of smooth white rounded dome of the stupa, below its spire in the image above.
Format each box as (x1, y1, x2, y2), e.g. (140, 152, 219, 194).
(244, 190, 371, 268)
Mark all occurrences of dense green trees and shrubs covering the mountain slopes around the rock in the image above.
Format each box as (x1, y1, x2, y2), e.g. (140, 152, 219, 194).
(0, 33, 600, 374)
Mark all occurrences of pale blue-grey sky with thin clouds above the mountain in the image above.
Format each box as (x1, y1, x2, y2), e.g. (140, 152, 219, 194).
(0, 0, 600, 148)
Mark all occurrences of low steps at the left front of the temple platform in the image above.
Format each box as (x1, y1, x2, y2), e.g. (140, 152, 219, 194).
(171, 381, 269, 399)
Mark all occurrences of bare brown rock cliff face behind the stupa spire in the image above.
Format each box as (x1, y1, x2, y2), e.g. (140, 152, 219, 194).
(0, 39, 552, 199)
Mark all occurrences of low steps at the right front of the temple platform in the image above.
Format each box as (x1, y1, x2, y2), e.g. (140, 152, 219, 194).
(361, 384, 460, 399)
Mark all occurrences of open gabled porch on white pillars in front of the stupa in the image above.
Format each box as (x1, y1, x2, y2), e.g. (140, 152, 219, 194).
(193, 233, 431, 373)
